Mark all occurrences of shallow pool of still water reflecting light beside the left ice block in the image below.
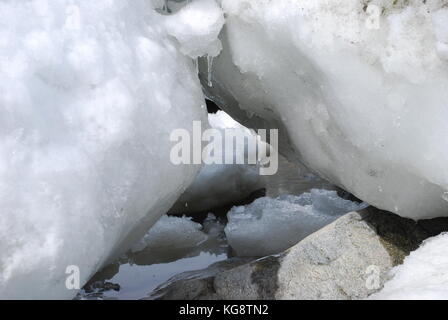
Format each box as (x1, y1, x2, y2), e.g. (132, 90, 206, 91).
(76, 215, 229, 300)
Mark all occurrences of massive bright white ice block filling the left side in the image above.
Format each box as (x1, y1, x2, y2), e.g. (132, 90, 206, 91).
(0, 0, 219, 299)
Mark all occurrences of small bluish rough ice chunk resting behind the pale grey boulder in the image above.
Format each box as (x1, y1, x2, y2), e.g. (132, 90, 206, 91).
(225, 189, 366, 257)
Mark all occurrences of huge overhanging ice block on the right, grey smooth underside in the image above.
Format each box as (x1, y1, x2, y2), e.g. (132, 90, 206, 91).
(201, 0, 448, 219)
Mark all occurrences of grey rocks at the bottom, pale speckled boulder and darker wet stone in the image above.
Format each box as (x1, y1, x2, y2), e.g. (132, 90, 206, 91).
(150, 207, 448, 300)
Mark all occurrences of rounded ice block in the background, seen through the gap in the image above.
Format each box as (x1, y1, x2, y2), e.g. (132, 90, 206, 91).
(171, 111, 265, 214)
